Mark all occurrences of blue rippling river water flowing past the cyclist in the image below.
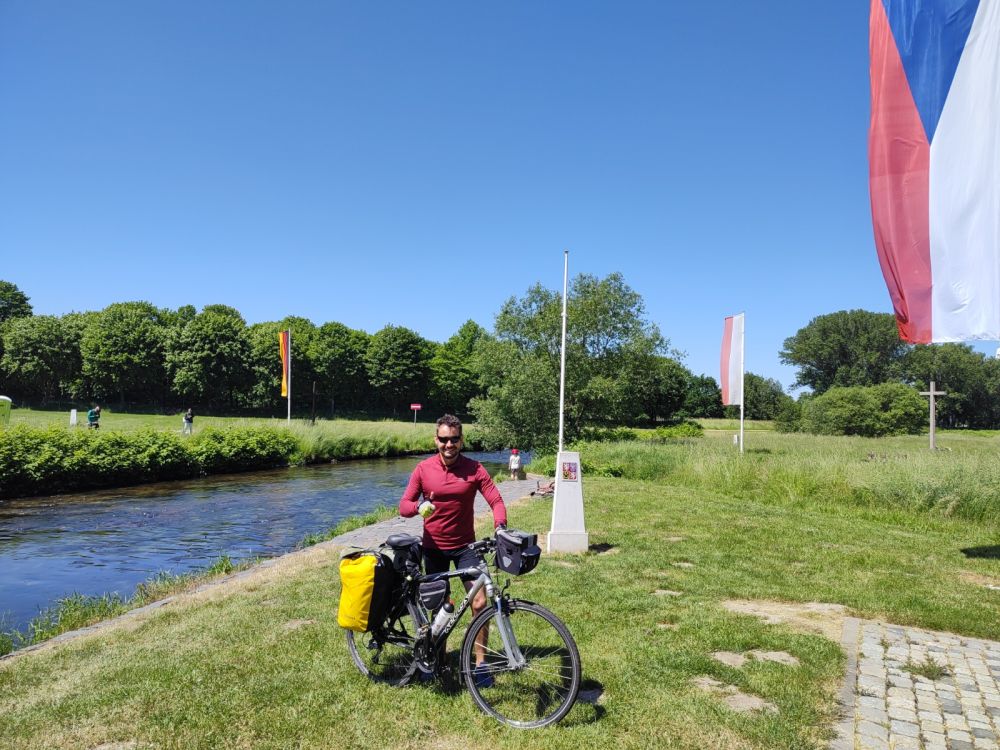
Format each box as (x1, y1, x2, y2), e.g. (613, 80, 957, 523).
(0, 453, 507, 632)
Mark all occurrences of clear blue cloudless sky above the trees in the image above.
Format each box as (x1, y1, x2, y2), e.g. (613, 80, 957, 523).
(0, 0, 994, 394)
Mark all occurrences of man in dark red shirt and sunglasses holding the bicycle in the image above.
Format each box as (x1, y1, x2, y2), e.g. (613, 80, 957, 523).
(399, 414, 507, 687)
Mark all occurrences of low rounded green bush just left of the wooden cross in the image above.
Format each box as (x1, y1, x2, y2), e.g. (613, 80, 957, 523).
(802, 383, 927, 437)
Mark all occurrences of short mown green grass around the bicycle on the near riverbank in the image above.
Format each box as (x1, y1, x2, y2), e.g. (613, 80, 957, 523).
(0, 435, 1000, 750)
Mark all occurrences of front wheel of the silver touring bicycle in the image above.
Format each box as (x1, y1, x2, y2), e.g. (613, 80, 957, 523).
(462, 599, 580, 729)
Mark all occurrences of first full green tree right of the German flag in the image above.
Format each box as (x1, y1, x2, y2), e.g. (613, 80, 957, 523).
(309, 323, 371, 418)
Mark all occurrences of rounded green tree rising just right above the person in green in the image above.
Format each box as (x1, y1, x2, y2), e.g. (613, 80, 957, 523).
(80, 302, 168, 404)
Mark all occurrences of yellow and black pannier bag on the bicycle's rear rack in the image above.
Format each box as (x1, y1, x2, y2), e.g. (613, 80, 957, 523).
(337, 550, 396, 632)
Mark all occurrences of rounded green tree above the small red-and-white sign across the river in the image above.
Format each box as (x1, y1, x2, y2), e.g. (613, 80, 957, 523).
(365, 325, 432, 414)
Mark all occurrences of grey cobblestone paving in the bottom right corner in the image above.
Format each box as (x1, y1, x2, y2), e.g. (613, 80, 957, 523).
(832, 618, 1000, 750)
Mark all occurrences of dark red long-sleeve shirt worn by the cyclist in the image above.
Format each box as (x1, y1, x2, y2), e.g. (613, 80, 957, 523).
(399, 454, 507, 550)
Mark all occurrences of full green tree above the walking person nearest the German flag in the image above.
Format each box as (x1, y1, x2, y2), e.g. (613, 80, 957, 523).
(166, 305, 251, 408)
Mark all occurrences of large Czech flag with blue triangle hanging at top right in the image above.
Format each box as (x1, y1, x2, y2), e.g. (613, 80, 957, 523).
(868, 0, 1000, 343)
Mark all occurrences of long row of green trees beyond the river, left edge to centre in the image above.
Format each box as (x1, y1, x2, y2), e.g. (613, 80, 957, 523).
(0, 274, 752, 446)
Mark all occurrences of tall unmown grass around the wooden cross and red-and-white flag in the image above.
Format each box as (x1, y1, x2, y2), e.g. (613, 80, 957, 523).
(534, 432, 1000, 525)
